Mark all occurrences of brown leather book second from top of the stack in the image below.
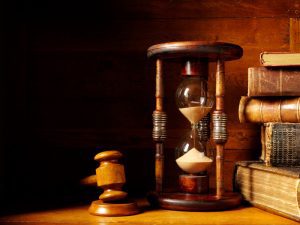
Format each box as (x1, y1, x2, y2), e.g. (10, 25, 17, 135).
(248, 67, 300, 96)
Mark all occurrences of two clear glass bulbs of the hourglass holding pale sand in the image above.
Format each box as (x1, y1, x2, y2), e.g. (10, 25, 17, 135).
(176, 61, 214, 174)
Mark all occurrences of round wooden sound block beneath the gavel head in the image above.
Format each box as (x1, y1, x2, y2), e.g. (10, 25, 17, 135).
(89, 200, 140, 216)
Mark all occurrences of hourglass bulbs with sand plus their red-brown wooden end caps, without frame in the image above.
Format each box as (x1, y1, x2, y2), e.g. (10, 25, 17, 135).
(175, 66, 214, 193)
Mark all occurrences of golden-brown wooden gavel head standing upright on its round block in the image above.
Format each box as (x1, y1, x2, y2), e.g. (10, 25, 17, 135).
(94, 150, 127, 202)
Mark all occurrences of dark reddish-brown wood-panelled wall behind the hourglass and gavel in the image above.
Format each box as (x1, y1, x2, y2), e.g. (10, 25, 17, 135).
(0, 0, 300, 213)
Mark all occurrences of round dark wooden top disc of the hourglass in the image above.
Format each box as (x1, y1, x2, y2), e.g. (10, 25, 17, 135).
(147, 41, 243, 61)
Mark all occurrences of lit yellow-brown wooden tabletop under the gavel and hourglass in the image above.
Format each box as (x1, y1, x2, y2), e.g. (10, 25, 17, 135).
(0, 206, 299, 225)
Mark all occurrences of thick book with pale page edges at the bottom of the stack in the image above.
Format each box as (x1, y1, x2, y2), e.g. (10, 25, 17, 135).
(234, 161, 300, 221)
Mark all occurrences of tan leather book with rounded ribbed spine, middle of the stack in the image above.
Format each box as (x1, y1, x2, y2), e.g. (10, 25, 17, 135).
(239, 96, 300, 123)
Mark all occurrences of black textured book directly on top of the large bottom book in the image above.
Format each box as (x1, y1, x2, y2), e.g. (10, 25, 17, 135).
(261, 123, 300, 167)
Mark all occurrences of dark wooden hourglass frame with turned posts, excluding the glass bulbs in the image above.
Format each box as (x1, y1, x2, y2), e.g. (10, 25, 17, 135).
(147, 41, 243, 211)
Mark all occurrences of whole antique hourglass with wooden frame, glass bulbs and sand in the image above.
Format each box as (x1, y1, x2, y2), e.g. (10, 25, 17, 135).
(148, 41, 243, 211)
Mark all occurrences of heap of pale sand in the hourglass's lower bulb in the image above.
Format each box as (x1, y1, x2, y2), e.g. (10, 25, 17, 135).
(176, 148, 212, 173)
